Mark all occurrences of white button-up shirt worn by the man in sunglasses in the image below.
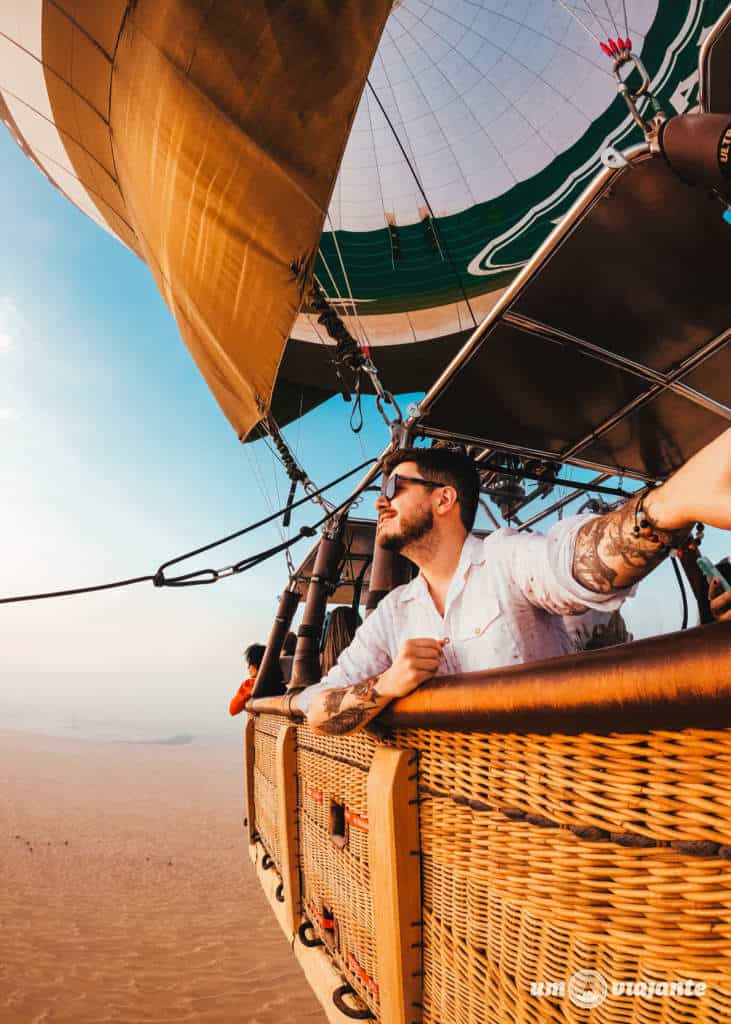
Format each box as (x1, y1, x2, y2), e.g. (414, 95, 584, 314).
(295, 515, 634, 714)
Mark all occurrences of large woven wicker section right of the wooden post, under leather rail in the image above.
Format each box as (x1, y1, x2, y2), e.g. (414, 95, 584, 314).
(394, 730, 731, 1024)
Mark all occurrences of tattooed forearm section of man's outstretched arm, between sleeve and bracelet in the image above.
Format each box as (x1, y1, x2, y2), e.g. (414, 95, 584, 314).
(573, 499, 688, 594)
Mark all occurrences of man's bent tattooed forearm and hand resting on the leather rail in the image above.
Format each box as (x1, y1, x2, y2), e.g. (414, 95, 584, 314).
(307, 637, 445, 736)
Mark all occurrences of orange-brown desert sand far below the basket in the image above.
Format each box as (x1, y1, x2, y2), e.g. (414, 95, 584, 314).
(0, 731, 326, 1024)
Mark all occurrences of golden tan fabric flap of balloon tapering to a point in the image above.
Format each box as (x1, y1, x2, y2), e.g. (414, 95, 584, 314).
(31, 0, 391, 438)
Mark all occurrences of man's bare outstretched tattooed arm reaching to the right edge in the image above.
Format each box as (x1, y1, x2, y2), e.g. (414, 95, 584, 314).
(572, 429, 731, 594)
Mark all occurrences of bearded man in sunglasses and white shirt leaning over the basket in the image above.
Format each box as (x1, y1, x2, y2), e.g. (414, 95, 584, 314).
(295, 430, 731, 735)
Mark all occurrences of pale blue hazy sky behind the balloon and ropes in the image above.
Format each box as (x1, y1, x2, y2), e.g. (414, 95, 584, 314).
(0, 131, 726, 732)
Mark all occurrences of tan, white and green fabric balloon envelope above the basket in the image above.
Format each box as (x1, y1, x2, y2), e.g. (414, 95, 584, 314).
(0, 0, 723, 458)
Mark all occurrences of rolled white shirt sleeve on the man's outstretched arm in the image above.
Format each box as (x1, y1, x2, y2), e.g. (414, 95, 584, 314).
(503, 515, 636, 615)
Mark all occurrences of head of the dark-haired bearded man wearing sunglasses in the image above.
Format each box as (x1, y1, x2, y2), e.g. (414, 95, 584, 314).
(376, 447, 480, 554)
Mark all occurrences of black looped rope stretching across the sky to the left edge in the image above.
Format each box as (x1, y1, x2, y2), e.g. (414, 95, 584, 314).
(0, 459, 378, 604)
